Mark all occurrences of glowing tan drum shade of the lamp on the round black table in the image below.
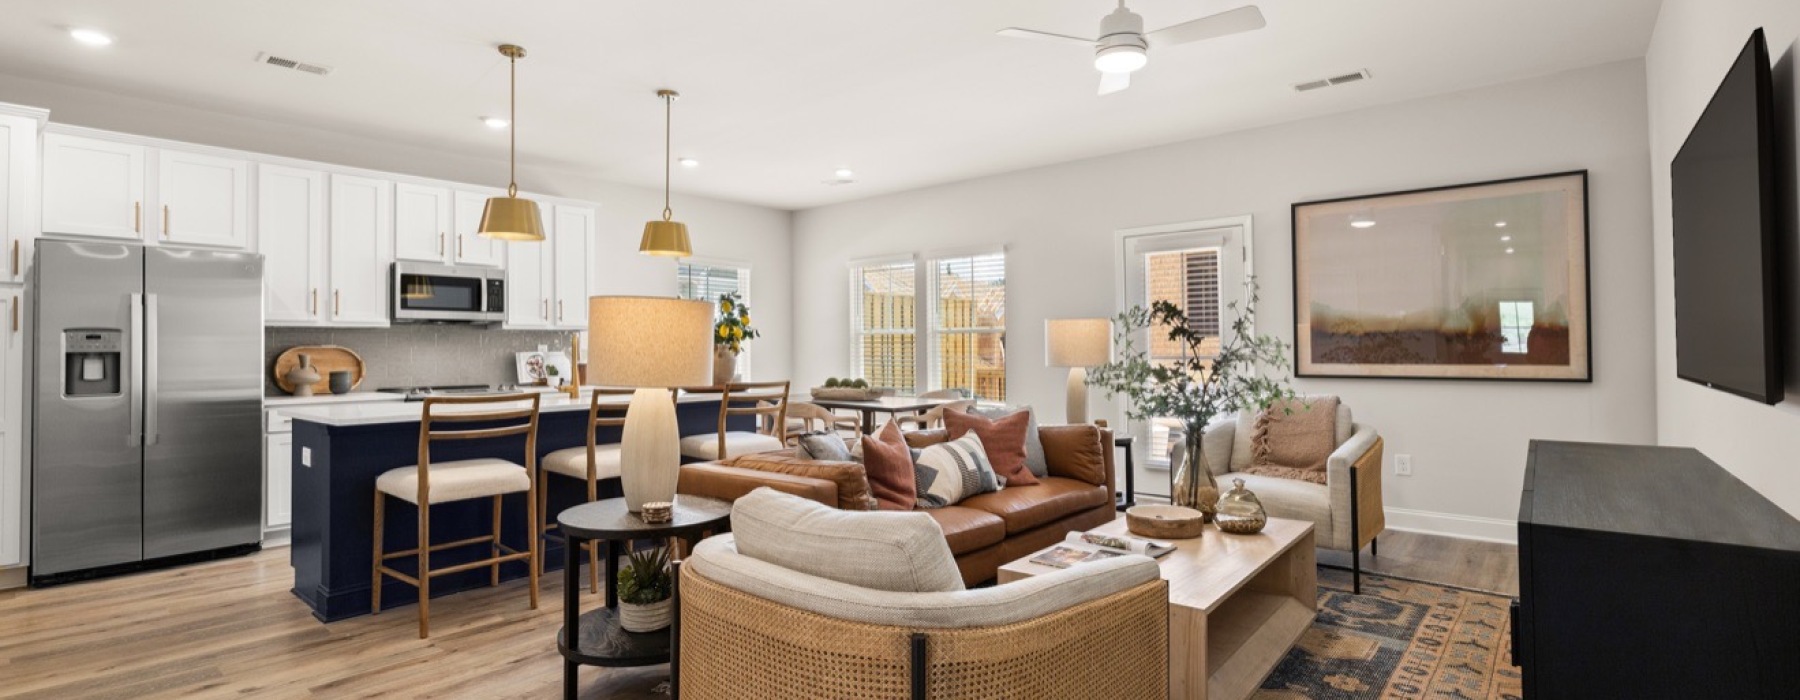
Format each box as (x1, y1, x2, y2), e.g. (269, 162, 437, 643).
(587, 297, 713, 387)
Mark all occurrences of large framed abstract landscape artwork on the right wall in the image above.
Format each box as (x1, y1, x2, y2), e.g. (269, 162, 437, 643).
(1294, 171, 1593, 381)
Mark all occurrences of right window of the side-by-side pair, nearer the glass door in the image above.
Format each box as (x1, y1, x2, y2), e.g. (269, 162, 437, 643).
(929, 252, 1006, 401)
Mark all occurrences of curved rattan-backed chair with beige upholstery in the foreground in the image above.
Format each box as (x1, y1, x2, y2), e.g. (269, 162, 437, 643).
(675, 489, 1168, 700)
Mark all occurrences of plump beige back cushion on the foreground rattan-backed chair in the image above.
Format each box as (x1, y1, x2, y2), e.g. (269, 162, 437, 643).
(731, 488, 963, 592)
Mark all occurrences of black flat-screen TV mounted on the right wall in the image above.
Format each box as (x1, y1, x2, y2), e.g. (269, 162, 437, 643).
(1670, 29, 1784, 403)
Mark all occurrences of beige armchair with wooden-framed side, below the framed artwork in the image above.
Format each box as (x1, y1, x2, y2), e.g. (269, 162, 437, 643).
(1202, 392, 1388, 594)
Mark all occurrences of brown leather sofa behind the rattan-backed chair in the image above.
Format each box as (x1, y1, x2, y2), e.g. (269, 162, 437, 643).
(679, 425, 1116, 585)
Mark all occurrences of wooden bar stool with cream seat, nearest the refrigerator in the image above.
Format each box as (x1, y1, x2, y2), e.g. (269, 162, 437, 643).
(373, 394, 538, 639)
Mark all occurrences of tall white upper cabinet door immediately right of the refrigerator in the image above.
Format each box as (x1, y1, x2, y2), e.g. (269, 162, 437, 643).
(256, 166, 326, 326)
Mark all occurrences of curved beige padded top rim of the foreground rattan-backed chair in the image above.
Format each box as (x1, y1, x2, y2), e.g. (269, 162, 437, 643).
(682, 533, 1161, 630)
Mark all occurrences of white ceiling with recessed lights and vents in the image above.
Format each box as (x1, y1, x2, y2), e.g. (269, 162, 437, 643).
(0, 0, 1661, 209)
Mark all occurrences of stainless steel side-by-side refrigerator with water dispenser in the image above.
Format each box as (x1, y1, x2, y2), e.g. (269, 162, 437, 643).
(31, 241, 263, 585)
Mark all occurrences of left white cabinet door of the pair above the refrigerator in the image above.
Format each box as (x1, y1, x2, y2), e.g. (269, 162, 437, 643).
(43, 133, 146, 238)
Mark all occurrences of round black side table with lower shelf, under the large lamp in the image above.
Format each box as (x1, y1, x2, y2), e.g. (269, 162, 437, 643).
(556, 495, 731, 700)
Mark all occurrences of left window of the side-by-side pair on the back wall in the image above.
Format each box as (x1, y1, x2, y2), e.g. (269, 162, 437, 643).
(850, 261, 918, 394)
